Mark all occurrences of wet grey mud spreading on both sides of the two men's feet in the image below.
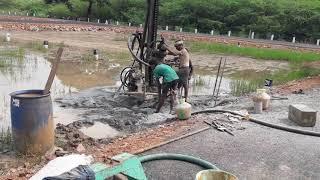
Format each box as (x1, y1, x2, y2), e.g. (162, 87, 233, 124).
(55, 87, 232, 141)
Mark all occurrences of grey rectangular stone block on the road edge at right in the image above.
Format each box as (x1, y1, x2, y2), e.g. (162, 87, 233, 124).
(289, 104, 317, 127)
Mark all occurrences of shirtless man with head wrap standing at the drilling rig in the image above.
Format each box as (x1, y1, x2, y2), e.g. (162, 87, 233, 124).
(165, 40, 193, 102)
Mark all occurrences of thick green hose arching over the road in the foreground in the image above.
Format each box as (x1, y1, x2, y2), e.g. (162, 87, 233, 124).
(139, 153, 219, 170)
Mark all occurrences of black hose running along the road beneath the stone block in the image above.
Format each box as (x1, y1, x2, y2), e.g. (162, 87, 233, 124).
(192, 109, 320, 137)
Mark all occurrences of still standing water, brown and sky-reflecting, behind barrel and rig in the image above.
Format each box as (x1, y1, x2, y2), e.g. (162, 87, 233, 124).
(0, 47, 244, 134)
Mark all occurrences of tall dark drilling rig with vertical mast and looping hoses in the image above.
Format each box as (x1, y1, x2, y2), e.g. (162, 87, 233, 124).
(117, 0, 166, 97)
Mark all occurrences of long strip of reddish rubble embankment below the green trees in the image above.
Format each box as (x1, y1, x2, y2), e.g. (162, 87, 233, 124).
(0, 16, 320, 52)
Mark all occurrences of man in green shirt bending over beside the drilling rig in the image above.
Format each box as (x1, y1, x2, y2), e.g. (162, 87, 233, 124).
(149, 60, 179, 113)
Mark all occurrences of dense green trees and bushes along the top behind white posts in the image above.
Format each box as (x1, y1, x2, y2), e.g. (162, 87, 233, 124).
(0, 0, 320, 43)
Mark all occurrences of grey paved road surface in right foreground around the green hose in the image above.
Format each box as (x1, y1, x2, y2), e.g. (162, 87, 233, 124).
(144, 122, 320, 180)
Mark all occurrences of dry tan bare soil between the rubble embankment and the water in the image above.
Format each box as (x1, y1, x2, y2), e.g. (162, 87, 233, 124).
(2, 31, 288, 72)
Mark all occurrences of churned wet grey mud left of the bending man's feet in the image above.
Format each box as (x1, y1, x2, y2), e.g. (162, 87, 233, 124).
(56, 88, 172, 133)
